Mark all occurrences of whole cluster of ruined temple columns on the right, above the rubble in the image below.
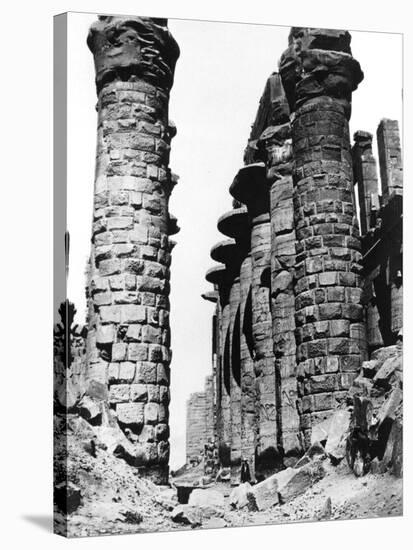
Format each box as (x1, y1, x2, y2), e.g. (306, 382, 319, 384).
(192, 28, 403, 485)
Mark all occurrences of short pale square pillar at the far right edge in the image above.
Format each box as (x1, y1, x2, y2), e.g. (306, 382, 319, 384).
(377, 118, 403, 204)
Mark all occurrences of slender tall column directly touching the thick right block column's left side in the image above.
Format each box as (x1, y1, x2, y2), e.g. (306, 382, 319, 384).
(258, 73, 302, 464)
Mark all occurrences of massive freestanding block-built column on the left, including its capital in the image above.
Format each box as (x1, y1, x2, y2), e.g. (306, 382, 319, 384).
(88, 16, 179, 483)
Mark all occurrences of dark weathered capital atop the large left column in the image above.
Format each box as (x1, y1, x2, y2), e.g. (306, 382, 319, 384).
(87, 16, 179, 93)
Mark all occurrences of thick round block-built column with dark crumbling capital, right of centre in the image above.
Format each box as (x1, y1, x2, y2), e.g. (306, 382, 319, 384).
(280, 28, 366, 446)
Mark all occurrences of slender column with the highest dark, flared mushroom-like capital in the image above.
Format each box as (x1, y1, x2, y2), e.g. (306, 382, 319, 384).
(230, 163, 279, 476)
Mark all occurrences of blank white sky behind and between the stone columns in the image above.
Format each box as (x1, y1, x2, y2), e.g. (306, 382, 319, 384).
(68, 13, 402, 468)
